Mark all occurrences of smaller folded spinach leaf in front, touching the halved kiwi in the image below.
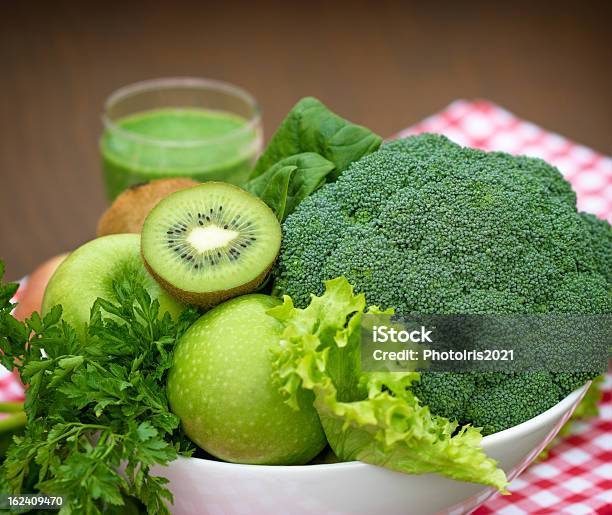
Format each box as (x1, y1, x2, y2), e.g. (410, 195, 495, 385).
(245, 152, 334, 222)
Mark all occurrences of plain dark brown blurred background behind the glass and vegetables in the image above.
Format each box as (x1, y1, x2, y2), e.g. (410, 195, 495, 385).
(0, 0, 612, 279)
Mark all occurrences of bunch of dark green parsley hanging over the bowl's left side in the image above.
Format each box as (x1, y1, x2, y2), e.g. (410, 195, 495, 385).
(0, 269, 197, 514)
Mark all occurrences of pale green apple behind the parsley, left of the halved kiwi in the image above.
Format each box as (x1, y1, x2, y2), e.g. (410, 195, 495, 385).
(42, 234, 184, 332)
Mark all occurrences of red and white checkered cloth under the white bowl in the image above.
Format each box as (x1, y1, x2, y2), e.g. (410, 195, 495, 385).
(0, 100, 612, 515)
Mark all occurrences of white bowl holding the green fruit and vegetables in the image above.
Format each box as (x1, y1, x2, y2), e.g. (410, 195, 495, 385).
(153, 384, 588, 515)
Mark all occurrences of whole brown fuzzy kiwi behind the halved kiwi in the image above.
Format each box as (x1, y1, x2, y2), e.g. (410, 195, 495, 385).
(97, 178, 200, 236)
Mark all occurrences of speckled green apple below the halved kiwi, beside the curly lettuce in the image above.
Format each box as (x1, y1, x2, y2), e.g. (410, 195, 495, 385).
(168, 294, 326, 465)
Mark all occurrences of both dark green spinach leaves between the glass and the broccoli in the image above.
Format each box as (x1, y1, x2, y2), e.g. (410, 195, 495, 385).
(245, 97, 382, 221)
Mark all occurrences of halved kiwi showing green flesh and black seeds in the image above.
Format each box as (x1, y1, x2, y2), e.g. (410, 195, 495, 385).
(141, 182, 281, 307)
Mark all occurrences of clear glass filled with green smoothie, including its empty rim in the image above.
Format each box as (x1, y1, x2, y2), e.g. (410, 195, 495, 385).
(100, 78, 263, 201)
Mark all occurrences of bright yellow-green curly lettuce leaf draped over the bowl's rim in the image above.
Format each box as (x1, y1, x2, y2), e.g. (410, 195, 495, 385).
(268, 277, 507, 492)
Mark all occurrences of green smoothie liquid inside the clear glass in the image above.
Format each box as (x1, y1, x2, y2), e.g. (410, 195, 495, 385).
(100, 108, 261, 201)
